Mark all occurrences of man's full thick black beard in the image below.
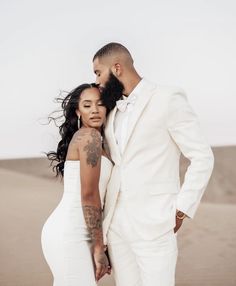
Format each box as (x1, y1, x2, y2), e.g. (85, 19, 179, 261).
(101, 72, 124, 111)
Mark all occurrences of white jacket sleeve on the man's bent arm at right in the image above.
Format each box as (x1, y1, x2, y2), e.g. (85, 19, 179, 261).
(167, 89, 214, 218)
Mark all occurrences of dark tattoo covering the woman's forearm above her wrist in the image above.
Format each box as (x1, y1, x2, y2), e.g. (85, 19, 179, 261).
(83, 205, 103, 244)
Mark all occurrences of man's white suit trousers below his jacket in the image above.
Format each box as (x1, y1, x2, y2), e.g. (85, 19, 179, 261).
(108, 200, 178, 286)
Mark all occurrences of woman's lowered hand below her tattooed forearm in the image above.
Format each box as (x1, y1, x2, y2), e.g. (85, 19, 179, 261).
(93, 250, 111, 281)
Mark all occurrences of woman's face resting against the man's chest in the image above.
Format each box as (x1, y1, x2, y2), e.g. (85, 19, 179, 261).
(76, 87, 106, 129)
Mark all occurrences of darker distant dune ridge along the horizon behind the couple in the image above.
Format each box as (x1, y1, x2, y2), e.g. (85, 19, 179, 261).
(0, 146, 236, 204)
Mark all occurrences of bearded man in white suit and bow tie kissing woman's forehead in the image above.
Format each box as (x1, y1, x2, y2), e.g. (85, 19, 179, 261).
(93, 43, 213, 286)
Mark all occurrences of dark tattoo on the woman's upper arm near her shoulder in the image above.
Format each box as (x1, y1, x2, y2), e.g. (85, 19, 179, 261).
(84, 129, 101, 167)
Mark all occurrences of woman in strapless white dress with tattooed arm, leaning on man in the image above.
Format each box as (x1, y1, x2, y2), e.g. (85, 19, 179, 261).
(42, 84, 112, 286)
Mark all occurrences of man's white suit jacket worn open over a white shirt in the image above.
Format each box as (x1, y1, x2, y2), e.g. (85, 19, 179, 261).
(103, 79, 214, 243)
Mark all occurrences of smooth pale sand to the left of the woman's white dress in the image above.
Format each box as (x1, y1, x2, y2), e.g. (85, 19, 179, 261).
(0, 169, 62, 286)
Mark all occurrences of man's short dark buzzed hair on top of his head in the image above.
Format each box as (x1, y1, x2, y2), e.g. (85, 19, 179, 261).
(93, 43, 133, 62)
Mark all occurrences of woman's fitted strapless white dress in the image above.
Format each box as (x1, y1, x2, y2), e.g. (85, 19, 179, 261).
(41, 156, 112, 286)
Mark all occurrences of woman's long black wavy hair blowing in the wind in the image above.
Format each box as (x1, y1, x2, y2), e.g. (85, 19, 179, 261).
(47, 83, 104, 177)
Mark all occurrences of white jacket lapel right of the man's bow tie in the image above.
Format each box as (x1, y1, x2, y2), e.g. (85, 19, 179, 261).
(121, 80, 156, 152)
